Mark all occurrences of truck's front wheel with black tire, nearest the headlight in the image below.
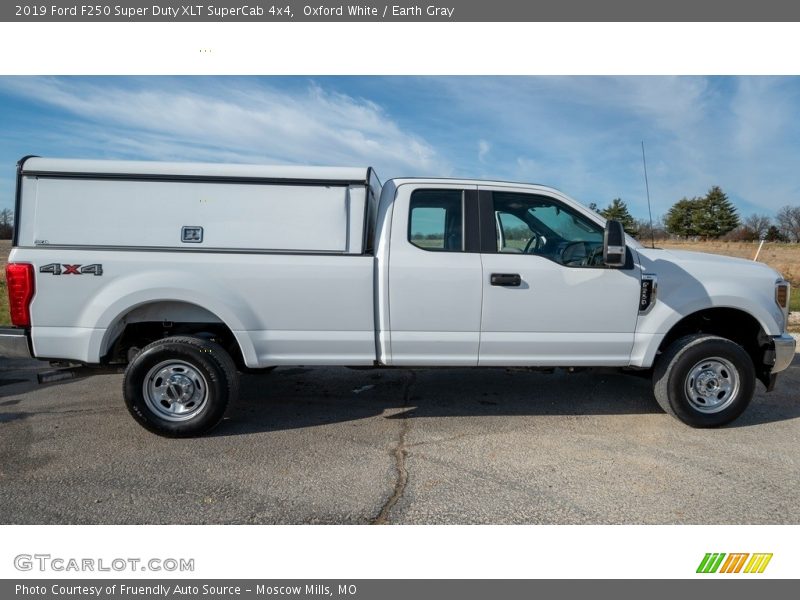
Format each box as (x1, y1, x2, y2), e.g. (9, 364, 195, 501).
(653, 334, 756, 427)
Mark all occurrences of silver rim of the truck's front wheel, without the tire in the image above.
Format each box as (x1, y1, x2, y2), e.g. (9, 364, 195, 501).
(684, 356, 739, 414)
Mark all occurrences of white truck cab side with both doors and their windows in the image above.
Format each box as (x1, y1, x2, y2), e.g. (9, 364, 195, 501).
(379, 180, 641, 367)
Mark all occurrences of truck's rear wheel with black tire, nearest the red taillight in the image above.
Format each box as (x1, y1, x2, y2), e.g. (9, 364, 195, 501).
(122, 336, 238, 437)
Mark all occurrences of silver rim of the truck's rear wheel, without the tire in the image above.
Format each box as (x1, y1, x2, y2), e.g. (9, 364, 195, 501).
(142, 360, 208, 421)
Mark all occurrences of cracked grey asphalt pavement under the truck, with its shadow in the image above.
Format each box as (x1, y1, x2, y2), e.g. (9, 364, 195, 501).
(0, 356, 800, 524)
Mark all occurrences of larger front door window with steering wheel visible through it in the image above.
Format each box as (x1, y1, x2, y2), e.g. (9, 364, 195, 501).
(493, 192, 603, 267)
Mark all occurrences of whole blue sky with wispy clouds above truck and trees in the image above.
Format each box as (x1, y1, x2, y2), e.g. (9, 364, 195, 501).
(0, 76, 800, 217)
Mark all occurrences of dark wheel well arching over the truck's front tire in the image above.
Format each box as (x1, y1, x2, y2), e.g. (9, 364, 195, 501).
(658, 308, 770, 385)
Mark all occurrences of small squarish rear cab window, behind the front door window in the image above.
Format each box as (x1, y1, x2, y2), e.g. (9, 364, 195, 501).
(408, 190, 464, 252)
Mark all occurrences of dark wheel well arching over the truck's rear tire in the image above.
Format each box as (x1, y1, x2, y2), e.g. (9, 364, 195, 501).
(102, 301, 244, 367)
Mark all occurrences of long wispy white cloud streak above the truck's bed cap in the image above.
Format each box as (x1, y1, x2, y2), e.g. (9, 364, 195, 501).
(0, 78, 449, 174)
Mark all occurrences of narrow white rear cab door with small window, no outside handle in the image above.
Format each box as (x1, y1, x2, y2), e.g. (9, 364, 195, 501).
(388, 184, 483, 366)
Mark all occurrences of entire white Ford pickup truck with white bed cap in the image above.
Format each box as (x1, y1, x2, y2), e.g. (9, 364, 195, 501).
(0, 157, 795, 436)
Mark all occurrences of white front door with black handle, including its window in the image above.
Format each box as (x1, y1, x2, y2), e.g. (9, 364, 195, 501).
(479, 187, 641, 366)
